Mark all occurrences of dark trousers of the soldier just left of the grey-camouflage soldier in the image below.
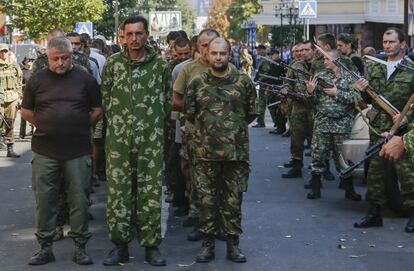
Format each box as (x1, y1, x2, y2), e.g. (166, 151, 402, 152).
(289, 104, 314, 161)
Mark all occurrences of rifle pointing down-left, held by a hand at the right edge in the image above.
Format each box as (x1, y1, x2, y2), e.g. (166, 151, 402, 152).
(340, 94, 414, 177)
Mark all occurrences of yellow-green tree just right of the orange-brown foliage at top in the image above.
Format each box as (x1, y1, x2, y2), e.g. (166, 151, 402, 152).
(227, 0, 262, 40)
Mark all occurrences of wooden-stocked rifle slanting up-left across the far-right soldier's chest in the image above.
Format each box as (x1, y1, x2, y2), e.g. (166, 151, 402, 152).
(315, 44, 400, 117)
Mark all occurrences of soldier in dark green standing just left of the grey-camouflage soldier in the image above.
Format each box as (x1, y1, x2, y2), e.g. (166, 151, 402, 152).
(282, 41, 315, 178)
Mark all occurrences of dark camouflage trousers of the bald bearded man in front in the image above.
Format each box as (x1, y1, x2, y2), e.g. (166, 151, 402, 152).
(194, 161, 249, 236)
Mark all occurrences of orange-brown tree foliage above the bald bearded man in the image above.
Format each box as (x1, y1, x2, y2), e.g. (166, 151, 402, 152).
(206, 0, 232, 38)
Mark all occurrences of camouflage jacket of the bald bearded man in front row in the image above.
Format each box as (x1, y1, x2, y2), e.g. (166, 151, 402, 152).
(184, 67, 256, 161)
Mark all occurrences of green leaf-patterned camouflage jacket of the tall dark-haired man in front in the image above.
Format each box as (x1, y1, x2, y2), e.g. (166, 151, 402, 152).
(101, 45, 172, 150)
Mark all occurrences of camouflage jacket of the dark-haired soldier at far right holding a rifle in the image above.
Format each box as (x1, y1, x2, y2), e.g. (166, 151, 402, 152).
(364, 58, 414, 132)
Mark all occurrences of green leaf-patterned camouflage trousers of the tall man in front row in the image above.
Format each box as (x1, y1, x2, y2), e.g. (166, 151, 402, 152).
(106, 145, 163, 247)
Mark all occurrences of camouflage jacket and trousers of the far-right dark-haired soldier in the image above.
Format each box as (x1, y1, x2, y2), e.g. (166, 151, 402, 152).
(366, 58, 414, 207)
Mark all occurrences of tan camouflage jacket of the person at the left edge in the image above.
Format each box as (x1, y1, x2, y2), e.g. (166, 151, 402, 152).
(0, 60, 23, 104)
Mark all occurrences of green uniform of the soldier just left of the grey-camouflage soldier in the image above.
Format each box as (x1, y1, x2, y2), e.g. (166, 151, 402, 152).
(286, 60, 314, 161)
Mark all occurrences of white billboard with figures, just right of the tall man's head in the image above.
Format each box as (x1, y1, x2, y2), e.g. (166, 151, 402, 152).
(149, 11, 182, 36)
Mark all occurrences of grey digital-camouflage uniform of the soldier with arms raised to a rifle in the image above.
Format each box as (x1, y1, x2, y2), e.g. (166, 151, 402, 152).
(311, 70, 360, 174)
